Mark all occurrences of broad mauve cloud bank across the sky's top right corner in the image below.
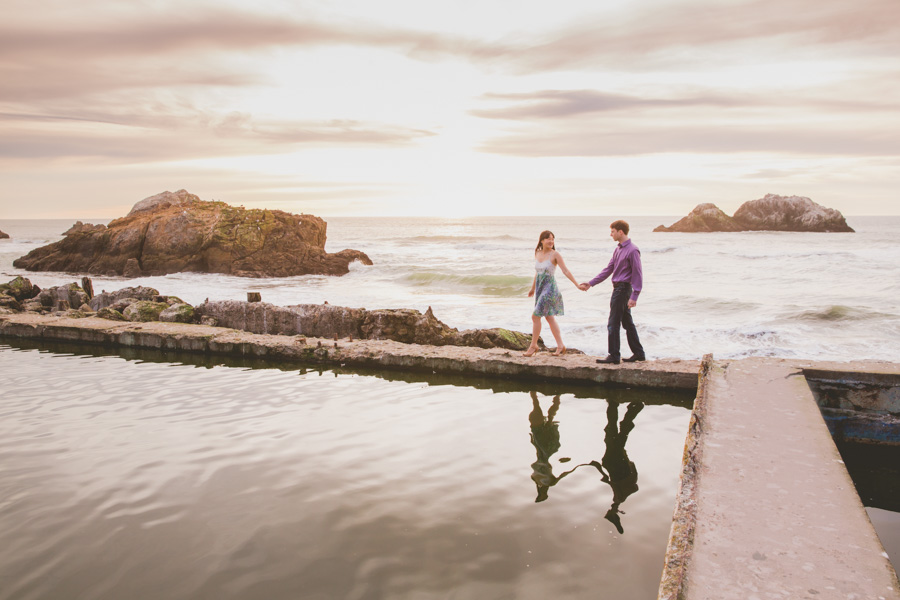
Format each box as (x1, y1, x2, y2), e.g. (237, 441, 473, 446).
(492, 0, 900, 72)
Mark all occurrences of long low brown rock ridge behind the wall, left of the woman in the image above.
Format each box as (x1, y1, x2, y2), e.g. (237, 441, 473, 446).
(195, 300, 531, 350)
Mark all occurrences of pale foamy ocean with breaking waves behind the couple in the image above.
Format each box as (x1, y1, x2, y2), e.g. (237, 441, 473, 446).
(0, 216, 900, 361)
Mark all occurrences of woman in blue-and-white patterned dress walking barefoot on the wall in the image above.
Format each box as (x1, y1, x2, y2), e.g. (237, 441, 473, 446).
(523, 231, 578, 356)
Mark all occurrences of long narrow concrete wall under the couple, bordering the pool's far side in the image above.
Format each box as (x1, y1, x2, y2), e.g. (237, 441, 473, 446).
(0, 314, 699, 390)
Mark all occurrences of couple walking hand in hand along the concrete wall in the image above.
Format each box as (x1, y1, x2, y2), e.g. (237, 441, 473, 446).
(524, 220, 646, 365)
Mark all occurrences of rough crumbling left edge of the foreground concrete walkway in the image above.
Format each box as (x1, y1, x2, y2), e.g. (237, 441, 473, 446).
(657, 354, 713, 600)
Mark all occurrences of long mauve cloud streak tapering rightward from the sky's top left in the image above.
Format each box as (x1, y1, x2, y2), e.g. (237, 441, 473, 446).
(0, 9, 500, 102)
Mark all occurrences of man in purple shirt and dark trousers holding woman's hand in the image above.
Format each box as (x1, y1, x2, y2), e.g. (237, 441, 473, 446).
(578, 221, 647, 365)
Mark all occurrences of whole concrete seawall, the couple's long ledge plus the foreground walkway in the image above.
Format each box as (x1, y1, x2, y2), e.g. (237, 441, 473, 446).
(0, 313, 900, 600)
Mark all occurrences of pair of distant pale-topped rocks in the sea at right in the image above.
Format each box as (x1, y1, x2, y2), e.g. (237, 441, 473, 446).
(653, 194, 853, 233)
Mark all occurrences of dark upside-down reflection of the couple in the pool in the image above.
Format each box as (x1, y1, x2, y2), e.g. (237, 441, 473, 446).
(528, 392, 644, 533)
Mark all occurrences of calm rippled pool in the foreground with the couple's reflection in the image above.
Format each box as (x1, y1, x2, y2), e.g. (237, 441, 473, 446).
(0, 345, 691, 600)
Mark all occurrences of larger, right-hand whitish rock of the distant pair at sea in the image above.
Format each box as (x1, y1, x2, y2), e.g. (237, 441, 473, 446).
(734, 194, 853, 233)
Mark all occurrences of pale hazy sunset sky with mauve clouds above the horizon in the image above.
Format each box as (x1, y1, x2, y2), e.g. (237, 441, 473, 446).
(0, 0, 900, 221)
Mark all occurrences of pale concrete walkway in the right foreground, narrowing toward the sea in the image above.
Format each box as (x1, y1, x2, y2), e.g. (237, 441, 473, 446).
(660, 359, 900, 600)
